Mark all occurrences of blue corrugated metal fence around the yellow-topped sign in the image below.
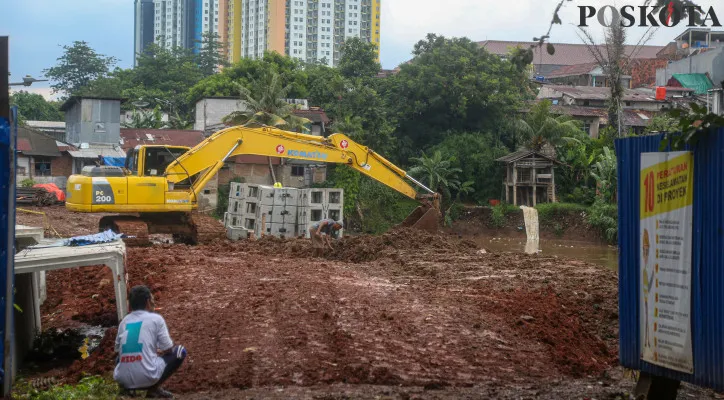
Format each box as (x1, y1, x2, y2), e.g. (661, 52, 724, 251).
(616, 129, 724, 390)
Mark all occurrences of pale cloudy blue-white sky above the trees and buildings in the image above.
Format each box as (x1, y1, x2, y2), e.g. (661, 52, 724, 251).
(0, 0, 724, 99)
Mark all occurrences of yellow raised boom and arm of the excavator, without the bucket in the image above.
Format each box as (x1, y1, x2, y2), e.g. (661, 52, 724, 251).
(166, 126, 434, 199)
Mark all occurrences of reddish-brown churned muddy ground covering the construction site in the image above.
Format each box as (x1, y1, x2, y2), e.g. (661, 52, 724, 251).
(18, 208, 711, 399)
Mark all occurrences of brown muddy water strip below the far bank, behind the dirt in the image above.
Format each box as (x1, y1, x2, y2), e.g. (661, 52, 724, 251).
(470, 236, 618, 271)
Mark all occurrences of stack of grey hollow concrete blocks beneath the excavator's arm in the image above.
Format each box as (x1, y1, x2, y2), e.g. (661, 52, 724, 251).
(224, 183, 344, 240)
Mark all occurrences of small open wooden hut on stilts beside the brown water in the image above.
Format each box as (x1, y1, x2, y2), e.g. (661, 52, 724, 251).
(496, 150, 562, 207)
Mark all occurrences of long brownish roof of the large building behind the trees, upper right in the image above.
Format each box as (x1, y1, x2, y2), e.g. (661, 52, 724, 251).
(478, 40, 664, 65)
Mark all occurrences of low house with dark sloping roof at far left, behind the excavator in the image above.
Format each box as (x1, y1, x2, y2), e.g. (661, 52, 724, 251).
(16, 127, 72, 189)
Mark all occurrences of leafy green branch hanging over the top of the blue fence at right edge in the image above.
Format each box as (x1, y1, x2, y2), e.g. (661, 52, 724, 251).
(659, 103, 724, 151)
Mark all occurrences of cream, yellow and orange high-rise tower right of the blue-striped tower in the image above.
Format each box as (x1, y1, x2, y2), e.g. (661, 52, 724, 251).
(227, 0, 381, 66)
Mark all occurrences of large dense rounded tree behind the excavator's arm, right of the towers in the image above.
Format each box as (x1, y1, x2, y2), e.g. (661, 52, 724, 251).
(382, 34, 532, 162)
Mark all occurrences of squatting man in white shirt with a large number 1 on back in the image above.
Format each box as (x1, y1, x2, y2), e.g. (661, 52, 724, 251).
(113, 285, 186, 398)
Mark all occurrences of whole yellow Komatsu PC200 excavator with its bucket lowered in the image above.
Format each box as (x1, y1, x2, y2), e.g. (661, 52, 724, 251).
(65, 126, 440, 244)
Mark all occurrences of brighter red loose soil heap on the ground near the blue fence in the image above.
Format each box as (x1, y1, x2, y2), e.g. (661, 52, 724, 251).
(496, 288, 617, 377)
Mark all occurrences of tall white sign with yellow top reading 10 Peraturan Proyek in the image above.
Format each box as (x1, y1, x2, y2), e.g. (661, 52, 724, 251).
(639, 151, 694, 374)
